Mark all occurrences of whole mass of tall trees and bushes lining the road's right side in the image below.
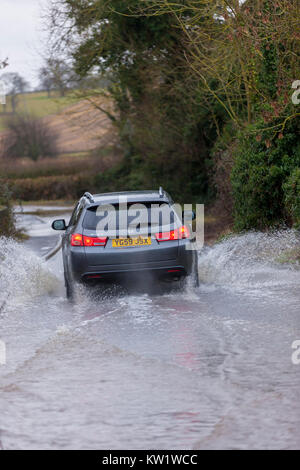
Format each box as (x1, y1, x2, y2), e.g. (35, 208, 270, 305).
(49, 0, 300, 230)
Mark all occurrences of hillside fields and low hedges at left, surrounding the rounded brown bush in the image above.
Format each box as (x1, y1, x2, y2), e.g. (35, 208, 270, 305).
(0, 92, 121, 201)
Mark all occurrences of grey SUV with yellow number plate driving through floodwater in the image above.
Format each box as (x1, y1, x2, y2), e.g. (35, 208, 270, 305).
(52, 188, 198, 298)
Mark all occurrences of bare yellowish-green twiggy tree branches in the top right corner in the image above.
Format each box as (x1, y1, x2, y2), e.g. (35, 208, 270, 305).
(140, 0, 299, 126)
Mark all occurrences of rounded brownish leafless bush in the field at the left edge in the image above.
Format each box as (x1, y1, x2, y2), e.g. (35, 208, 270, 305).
(1, 114, 58, 161)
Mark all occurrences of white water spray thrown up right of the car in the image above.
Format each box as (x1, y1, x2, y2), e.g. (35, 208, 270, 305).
(199, 230, 300, 295)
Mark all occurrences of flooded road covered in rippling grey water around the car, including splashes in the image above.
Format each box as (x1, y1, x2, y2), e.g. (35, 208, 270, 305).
(0, 208, 300, 450)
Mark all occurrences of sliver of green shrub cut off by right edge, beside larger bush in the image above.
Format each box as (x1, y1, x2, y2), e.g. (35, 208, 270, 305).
(283, 168, 300, 228)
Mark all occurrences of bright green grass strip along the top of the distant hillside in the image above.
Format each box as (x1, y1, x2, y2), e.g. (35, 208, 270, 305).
(0, 91, 79, 131)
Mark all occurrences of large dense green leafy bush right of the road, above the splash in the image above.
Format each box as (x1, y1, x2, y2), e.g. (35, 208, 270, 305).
(231, 115, 300, 230)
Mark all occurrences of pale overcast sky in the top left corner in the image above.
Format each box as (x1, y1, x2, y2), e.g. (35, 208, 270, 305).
(0, 0, 47, 86)
